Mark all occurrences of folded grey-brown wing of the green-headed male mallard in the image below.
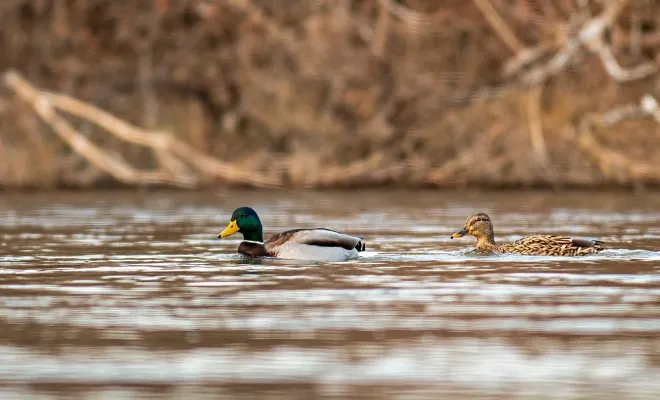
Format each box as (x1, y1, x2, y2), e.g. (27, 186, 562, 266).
(265, 228, 365, 251)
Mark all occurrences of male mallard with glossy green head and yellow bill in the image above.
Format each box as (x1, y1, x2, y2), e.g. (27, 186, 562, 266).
(218, 207, 365, 261)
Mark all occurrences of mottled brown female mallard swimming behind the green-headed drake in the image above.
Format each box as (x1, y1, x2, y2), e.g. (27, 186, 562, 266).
(450, 212, 603, 256)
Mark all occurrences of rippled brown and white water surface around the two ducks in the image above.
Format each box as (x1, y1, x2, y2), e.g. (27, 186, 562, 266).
(0, 191, 660, 399)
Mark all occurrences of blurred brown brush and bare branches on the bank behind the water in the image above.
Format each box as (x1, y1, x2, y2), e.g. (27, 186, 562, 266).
(0, 0, 660, 188)
